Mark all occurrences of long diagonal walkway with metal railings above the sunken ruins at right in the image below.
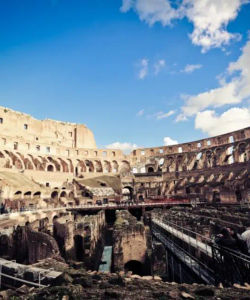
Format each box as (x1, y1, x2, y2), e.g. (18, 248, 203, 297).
(152, 218, 250, 286)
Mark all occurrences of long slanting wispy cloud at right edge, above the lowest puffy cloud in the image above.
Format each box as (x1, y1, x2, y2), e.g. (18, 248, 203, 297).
(176, 41, 250, 121)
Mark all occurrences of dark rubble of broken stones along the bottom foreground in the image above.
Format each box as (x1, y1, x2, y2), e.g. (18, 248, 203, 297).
(0, 266, 250, 300)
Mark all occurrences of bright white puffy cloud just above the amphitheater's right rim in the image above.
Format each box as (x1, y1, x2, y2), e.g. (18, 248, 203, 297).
(195, 107, 250, 136)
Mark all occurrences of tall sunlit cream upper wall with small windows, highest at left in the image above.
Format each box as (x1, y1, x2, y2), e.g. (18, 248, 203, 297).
(0, 107, 96, 153)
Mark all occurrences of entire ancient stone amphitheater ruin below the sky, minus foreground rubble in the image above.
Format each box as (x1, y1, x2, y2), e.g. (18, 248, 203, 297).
(0, 107, 250, 299)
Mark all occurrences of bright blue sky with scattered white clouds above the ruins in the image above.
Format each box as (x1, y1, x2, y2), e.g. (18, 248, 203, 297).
(0, 0, 250, 149)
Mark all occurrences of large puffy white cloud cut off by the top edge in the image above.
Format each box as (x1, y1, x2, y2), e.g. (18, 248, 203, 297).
(121, 0, 249, 52)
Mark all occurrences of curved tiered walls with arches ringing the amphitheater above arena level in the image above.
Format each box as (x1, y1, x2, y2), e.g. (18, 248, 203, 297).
(0, 107, 250, 209)
